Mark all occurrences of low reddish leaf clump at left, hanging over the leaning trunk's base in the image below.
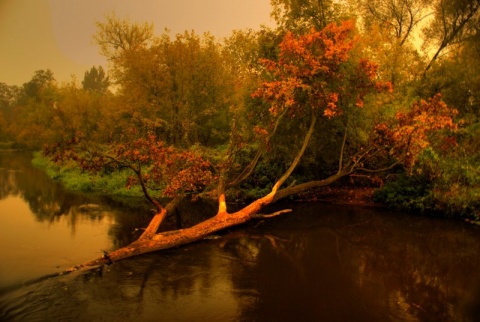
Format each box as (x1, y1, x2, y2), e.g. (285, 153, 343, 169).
(44, 133, 213, 203)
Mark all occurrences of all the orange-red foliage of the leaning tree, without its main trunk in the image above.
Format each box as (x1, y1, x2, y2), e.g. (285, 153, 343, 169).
(41, 21, 455, 216)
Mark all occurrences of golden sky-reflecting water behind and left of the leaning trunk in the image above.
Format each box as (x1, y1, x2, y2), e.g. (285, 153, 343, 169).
(0, 152, 148, 290)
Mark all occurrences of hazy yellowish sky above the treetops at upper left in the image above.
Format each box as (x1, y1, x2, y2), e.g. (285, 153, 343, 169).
(0, 0, 273, 85)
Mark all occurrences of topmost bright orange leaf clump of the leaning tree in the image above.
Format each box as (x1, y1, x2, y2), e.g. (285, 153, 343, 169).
(253, 21, 391, 118)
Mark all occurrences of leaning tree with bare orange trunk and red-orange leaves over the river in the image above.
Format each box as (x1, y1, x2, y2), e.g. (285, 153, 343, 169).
(54, 21, 456, 268)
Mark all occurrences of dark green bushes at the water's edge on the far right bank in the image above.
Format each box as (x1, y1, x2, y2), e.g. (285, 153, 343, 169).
(373, 149, 480, 221)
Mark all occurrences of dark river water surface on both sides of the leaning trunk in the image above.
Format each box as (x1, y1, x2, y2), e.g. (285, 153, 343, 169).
(0, 152, 480, 321)
